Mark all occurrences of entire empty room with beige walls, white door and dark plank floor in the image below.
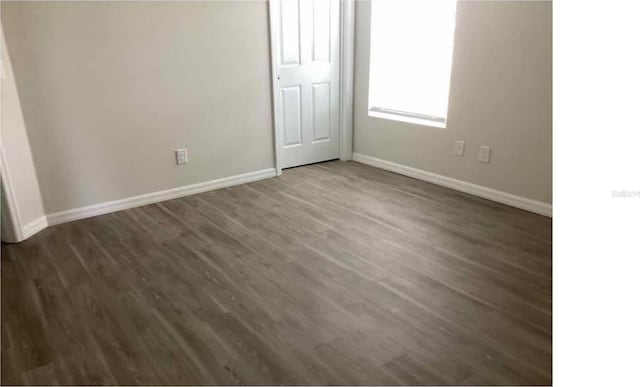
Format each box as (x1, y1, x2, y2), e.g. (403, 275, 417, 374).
(0, 0, 553, 385)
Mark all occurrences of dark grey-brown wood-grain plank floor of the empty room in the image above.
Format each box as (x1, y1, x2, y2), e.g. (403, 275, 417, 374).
(1, 162, 552, 385)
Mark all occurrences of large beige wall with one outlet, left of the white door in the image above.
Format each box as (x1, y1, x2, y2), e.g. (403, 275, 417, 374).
(1, 1, 273, 213)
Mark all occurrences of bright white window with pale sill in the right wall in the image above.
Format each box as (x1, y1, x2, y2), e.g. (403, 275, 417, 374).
(369, 0, 456, 128)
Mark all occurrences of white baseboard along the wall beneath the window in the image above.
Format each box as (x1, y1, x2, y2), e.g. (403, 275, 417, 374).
(353, 153, 552, 217)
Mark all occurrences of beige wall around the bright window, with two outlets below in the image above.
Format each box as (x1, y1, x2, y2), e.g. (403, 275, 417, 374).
(354, 1, 552, 203)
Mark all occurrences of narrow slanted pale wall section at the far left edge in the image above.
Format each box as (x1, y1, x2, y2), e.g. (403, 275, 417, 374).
(0, 26, 45, 242)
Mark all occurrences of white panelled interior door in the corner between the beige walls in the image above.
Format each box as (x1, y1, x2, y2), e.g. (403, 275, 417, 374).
(270, 0, 340, 168)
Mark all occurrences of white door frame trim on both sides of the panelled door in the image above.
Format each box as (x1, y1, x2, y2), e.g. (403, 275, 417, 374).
(269, 0, 355, 176)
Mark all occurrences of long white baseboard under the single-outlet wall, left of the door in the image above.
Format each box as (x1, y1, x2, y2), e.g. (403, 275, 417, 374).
(47, 168, 276, 226)
